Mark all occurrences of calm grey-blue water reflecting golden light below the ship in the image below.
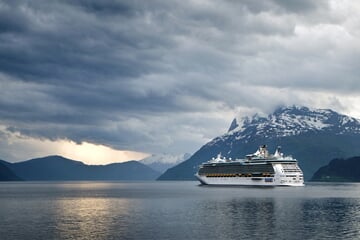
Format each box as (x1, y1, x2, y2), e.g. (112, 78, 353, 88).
(0, 182, 360, 240)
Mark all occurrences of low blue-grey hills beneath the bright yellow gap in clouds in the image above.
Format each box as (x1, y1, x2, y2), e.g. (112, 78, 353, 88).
(4, 156, 160, 180)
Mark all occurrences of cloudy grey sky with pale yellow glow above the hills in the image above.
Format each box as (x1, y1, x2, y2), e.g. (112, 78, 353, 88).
(0, 0, 360, 164)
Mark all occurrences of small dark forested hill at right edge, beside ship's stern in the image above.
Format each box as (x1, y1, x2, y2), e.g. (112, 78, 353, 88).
(311, 157, 360, 182)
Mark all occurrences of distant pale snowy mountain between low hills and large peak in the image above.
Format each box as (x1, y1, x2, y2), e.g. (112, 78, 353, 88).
(140, 153, 191, 173)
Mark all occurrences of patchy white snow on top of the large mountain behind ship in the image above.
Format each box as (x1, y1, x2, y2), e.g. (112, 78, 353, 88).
(225, 106, 360, 139)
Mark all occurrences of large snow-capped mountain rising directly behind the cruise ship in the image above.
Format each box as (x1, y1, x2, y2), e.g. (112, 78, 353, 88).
(159, 106, 360, 180)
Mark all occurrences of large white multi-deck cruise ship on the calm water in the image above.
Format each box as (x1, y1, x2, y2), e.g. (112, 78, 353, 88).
(195, 145, 304, 186)
